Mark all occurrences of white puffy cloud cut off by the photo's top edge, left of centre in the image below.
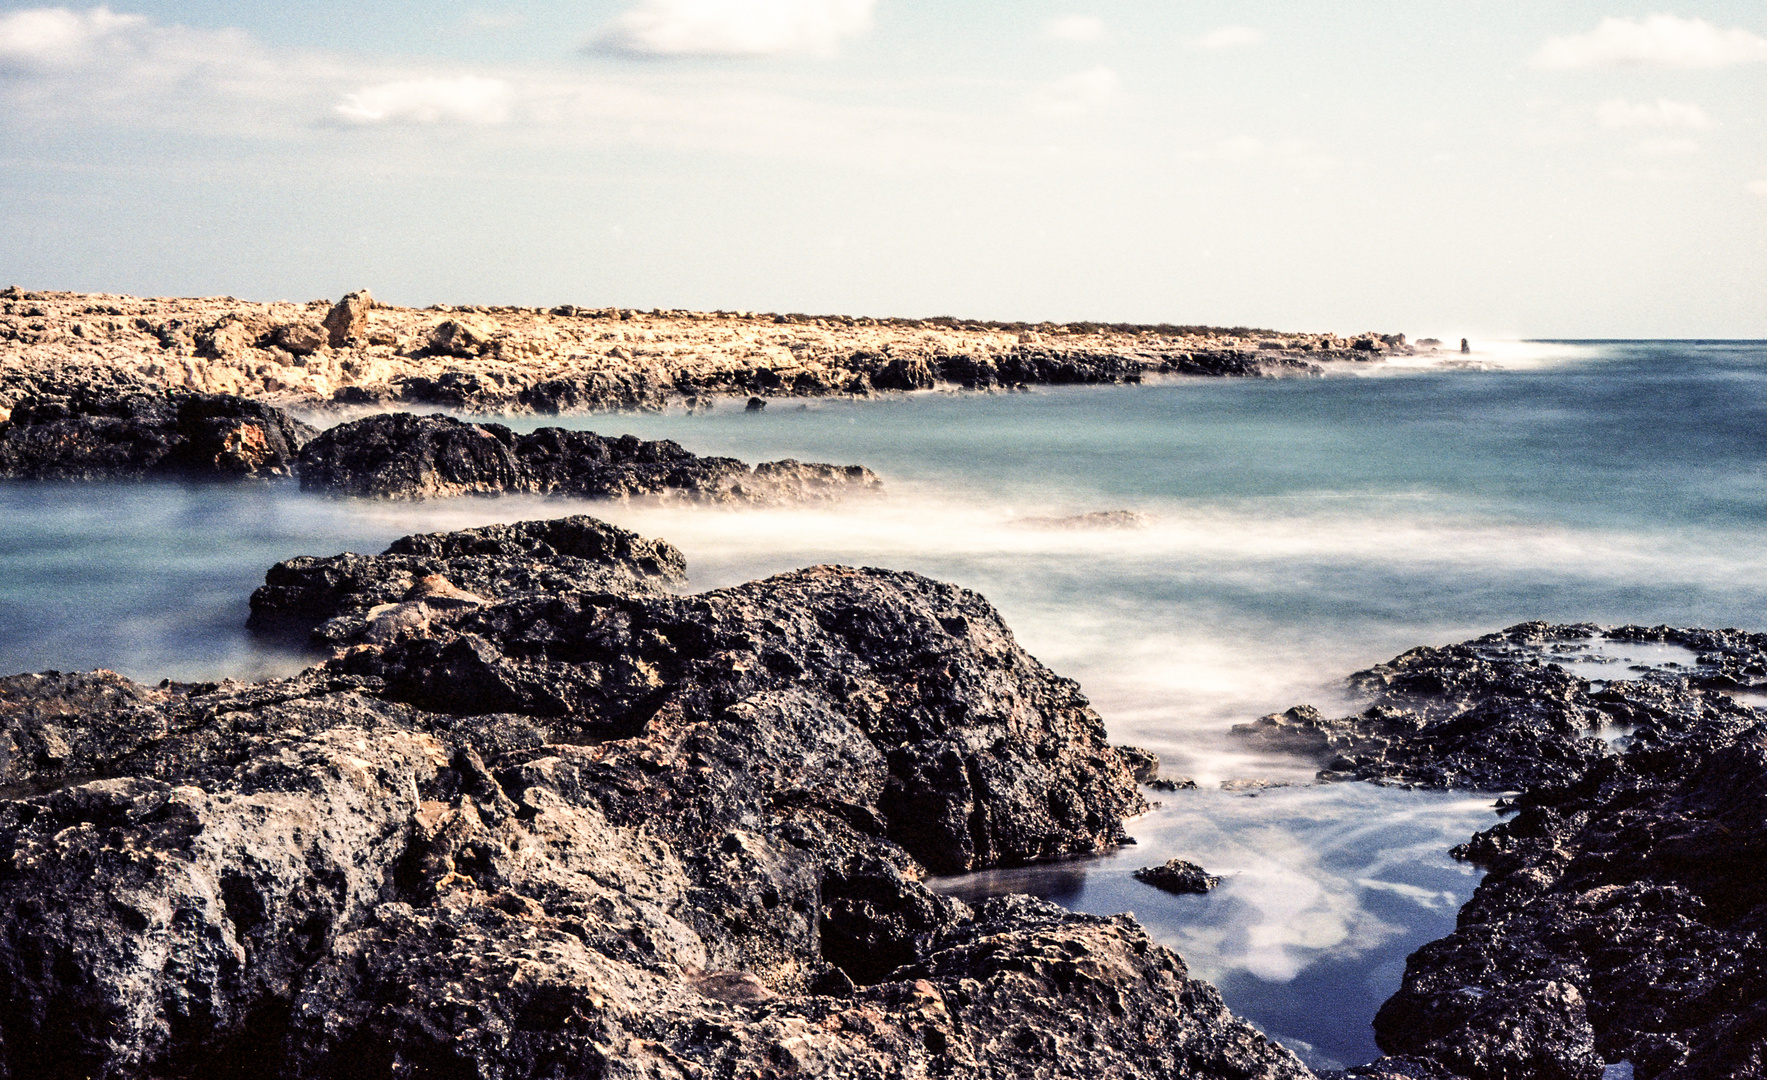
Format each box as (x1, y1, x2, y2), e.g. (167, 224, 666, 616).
(588, 0, 876, 57)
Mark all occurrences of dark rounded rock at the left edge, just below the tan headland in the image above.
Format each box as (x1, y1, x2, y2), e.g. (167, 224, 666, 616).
(0, 382, 316, 481)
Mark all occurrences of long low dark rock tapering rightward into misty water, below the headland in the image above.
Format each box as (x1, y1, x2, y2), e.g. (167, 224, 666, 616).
(300, 412, 882, 504)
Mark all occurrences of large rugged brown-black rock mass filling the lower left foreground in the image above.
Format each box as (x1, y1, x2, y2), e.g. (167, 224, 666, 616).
(0, 530, 1308, 1080)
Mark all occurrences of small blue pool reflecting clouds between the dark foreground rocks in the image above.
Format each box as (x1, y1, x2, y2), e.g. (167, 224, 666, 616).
(935, 783, 1497, 1069)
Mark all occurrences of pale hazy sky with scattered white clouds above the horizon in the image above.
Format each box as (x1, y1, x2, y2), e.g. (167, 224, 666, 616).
(0, 0, 1767, 338)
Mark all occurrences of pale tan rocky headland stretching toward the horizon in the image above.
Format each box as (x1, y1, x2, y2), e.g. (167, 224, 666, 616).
(0, 288, 1410, 414)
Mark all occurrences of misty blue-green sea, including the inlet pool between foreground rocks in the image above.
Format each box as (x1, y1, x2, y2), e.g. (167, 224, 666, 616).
(0, 341, 1767, 1068)
